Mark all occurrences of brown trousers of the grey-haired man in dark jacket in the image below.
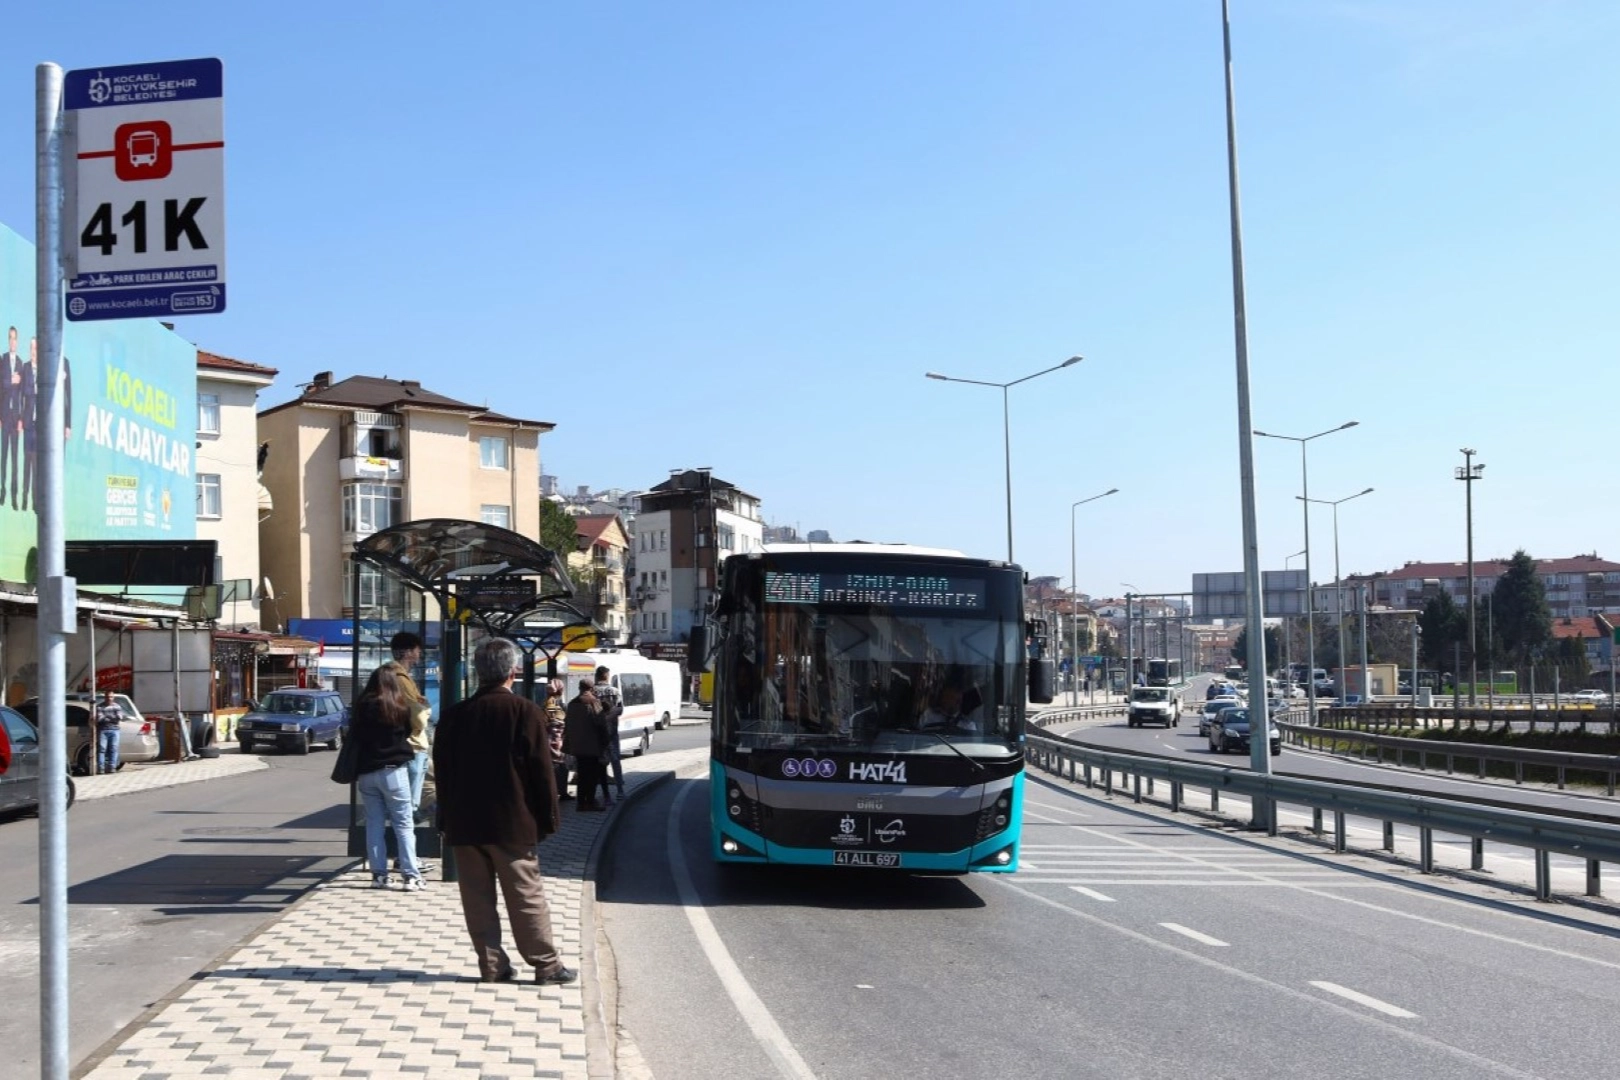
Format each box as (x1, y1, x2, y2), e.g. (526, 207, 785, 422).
(452, 844, 562, 980)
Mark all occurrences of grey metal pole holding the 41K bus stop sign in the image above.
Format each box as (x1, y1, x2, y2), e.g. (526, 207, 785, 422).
(34, 63, 72, 1080)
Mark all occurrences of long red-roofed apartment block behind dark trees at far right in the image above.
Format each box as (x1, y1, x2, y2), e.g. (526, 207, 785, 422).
(1345, 552, 1620, 619)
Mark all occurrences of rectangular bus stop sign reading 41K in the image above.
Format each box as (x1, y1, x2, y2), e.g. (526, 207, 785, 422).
(63, 60, 225, 321)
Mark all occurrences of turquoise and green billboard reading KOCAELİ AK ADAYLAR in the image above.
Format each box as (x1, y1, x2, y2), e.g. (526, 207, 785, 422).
(0, 225, 198, 581)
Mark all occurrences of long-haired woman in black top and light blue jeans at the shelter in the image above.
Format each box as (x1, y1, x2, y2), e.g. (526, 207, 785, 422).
(348, 661, 428, 891)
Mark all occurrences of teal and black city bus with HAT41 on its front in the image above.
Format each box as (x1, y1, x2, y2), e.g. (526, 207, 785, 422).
(692, 544, 1053, 873)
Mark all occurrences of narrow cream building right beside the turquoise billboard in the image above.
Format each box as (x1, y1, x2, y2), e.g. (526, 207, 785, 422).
(196, 350, 277, 630)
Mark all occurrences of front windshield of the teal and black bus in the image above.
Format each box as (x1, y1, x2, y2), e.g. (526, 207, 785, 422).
(716, 604, 1024, 756)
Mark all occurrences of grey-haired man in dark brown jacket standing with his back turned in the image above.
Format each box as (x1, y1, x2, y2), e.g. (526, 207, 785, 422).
(433, 638, 578, 984)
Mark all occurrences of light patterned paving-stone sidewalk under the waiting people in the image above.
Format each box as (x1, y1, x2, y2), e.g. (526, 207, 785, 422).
(75, 746, 708, 1080)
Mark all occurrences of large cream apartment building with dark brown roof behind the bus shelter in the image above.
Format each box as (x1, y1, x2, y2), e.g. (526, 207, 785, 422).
(259, 371, 554, 627)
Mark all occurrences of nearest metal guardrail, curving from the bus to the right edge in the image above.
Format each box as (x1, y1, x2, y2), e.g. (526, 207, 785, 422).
(1024, 725, 1620, 900)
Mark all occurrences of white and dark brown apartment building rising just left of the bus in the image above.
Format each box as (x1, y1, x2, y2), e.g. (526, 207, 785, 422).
(630, 470, 765, 643)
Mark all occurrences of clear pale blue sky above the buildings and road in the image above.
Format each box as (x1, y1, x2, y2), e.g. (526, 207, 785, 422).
(0, 0, 1620, 594)
